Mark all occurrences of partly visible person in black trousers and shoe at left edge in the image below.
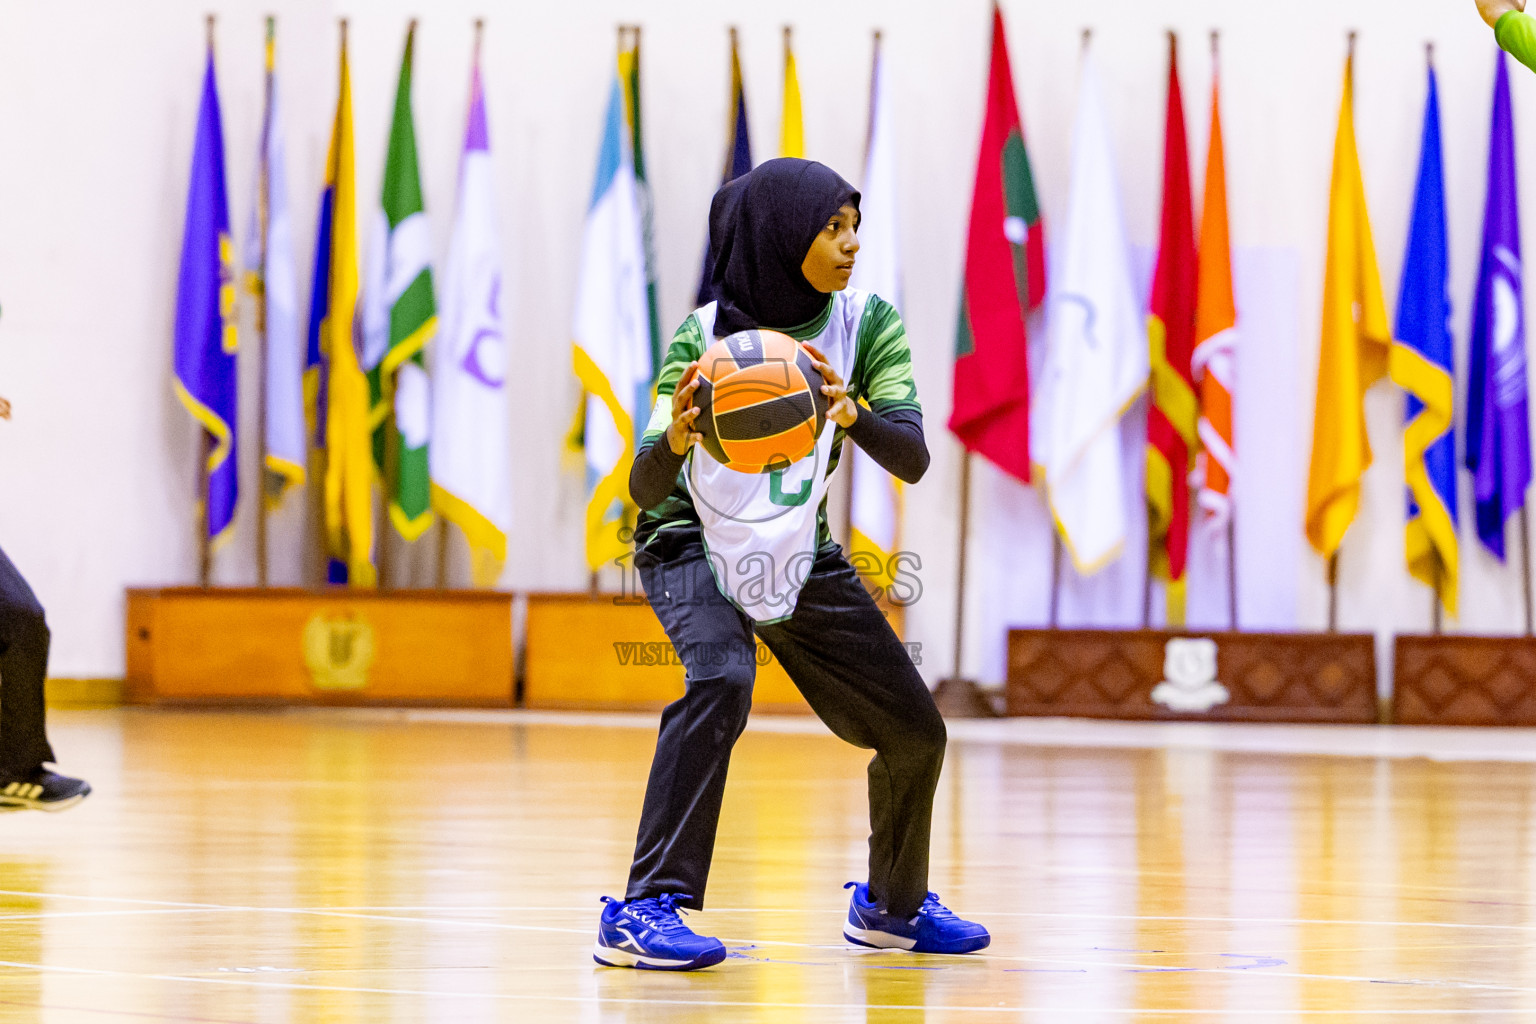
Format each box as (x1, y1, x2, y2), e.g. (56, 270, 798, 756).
(0, 398, 91, 811)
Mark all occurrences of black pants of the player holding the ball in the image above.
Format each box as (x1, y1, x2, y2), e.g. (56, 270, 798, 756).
(625, 540, 945, 917)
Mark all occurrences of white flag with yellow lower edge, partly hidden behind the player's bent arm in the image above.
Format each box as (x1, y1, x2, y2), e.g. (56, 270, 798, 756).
(848, 34, 902, 586)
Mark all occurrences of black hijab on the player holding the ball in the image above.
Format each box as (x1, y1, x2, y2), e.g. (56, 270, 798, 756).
(710, 157, 859, 338)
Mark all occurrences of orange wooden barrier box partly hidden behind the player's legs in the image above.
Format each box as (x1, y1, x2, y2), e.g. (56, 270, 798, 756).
(522, 593, 811, 714)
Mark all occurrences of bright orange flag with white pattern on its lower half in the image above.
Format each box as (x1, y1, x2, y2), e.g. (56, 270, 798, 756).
(1192, 47, 1238, 528)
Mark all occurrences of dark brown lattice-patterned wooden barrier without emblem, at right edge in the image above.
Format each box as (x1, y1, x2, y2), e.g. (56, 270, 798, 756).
(1392, 636, 1536, 726)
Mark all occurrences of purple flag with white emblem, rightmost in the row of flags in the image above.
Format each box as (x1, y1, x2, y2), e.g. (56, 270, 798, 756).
(1467, 51, 1531, 560)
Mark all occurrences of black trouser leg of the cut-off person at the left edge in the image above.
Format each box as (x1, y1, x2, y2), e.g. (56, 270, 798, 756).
(0, 551, 54, 777)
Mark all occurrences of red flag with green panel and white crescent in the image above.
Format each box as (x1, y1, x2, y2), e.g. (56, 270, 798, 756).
(949, 5, 1046, 481)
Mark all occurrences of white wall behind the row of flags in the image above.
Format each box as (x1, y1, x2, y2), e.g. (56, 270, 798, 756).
(0, 0, 1536, 682)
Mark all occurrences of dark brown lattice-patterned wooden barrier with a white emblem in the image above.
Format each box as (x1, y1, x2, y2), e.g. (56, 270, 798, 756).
(1006, 629, 1378, 723)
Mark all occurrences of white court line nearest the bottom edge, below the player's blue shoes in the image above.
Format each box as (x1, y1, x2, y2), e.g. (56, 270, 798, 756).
(0, 960, 1528, 1018)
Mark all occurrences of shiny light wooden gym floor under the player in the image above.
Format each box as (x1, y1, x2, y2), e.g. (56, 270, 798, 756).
(0, 709, 1536, 1024)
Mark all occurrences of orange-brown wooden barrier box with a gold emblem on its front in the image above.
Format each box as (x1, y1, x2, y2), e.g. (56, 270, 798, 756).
(124, 586, 513, 706)
